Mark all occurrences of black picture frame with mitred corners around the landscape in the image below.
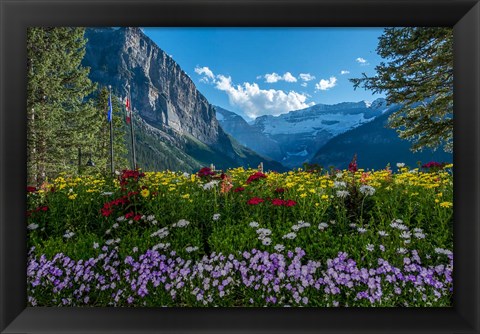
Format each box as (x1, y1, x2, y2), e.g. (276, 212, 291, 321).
(0, 0, 480, 334)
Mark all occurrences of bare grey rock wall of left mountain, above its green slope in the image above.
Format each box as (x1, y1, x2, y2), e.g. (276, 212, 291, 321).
(85, 28, 219, 145)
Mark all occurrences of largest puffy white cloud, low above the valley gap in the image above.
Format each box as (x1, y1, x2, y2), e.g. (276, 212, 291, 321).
(196, 67, 315, 119)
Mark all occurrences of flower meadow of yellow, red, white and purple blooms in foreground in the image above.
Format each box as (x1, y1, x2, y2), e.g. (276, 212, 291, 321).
(26, 162, 453, 307)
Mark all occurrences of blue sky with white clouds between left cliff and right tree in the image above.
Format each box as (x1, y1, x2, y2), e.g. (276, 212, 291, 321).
(143, 28, 383, 120)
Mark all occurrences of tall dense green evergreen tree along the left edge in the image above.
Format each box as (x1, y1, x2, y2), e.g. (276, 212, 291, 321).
(27, 27, 95, 185)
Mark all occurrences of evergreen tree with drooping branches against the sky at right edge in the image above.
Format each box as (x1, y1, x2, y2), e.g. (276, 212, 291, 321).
(350, 27, 453, 152)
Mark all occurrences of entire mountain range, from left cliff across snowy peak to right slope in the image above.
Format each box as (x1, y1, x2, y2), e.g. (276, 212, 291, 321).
(83, 28, 452, 171)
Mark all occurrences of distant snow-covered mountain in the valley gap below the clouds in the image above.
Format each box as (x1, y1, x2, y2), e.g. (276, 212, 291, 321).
(216, 99, 391, 168)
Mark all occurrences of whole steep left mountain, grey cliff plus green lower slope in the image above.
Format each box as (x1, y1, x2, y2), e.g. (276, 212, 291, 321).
(83, 28, 283, 170)
